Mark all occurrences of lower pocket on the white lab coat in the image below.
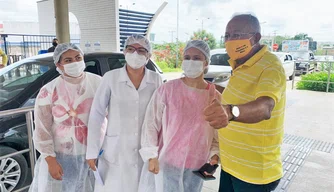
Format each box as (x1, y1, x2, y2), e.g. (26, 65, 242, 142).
(102, 135, 119, 165)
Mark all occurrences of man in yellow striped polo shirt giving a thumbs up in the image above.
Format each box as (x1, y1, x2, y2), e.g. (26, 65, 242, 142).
(204, 14, 286, 192)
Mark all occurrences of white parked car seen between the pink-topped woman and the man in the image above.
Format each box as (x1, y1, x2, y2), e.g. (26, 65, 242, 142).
(204, 49, 232, 90)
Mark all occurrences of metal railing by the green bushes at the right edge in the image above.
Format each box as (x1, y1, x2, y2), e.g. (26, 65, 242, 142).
(292, 61, 334, 93)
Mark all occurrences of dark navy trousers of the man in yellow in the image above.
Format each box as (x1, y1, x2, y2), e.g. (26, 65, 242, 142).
(219, 170, 280, 192)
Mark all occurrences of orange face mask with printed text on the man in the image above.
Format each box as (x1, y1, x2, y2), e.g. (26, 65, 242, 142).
(225, 36, 254, 61)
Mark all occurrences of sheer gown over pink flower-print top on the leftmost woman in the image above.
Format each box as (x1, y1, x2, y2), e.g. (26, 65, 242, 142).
(29, 73, 103, 192)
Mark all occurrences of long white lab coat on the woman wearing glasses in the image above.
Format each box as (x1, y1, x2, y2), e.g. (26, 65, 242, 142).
(86, 67, 162, 192)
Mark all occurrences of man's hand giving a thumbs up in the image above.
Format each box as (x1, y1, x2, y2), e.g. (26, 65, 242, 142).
(204, 84, 229, 129)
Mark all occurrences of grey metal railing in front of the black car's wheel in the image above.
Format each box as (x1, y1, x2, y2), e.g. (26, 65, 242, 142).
(0, 107, 37, 192)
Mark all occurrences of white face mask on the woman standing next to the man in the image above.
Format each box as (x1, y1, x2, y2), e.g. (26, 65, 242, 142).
(182, 60, 204, 79)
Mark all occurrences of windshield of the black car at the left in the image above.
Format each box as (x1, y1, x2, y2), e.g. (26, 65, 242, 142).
(0, 61, 54, 105)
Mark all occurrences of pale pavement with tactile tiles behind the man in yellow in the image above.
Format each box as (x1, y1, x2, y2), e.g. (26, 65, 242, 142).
(202, 90, 334, 192)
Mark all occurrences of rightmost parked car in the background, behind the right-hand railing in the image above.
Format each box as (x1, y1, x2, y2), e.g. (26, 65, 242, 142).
(290, 51, 317, 75)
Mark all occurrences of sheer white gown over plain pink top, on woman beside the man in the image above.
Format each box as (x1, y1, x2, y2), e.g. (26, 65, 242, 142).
(139, 79, 219, 192)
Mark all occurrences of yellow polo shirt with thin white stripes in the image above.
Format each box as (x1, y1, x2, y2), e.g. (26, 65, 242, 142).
(219, 46, 286, 184)
